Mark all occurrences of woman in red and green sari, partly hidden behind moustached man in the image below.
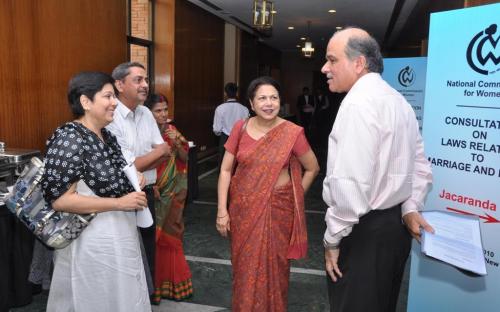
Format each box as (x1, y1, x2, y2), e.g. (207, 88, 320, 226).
(144, 94, 193, 304)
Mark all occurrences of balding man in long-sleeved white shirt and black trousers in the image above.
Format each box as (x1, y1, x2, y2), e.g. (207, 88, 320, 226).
(321, 28, 433, 312)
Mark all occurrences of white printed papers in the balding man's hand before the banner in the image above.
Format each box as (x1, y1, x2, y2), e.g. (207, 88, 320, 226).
(422, 211, 487, 275)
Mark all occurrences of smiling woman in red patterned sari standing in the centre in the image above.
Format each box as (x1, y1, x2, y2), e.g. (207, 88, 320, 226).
(216, 77, 319, 312)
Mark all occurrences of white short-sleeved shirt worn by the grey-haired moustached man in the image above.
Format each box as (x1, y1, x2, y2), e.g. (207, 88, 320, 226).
(106, 100, 164, 185)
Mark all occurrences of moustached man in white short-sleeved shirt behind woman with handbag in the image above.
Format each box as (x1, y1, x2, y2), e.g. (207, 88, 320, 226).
(107, 62, 171, 298)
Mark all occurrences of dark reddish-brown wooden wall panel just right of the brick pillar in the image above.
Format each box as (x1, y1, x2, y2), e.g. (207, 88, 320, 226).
(174, 0, 224, 156)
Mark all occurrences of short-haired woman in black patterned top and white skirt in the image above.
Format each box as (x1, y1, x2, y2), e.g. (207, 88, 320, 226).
(42, 72, 151, 312)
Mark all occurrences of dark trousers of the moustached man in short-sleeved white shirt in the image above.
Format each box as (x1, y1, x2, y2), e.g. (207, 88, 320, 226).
(140, 185, 158, 287)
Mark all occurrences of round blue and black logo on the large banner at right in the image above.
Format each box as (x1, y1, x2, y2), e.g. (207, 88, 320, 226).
(467, 24, 500, 75)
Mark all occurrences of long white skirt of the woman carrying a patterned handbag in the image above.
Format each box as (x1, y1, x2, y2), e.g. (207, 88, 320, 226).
(47, 183, 151, 312)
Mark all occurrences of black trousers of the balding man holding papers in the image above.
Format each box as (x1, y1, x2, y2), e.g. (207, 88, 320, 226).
(327, 205, 411, 312)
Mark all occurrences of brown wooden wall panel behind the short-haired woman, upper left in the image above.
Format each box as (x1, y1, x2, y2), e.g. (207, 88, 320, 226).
(0, 0, 127, 150)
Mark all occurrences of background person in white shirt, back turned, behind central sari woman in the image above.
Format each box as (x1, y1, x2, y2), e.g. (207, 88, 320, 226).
(213, 82, 249, 167)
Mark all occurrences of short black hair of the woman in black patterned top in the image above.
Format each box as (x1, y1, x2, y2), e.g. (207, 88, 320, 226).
(68, 72, 114, 118)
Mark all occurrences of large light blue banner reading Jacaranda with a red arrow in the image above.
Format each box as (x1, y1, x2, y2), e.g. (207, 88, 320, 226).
(408, 4, 500, 312)
